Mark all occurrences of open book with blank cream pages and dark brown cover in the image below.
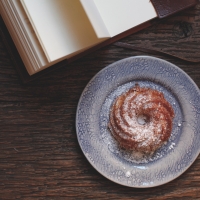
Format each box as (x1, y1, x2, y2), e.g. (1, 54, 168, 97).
(0, 0, 197, 76)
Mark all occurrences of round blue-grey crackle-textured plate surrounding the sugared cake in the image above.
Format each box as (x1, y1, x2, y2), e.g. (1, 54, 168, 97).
(76, 56, 200, 188)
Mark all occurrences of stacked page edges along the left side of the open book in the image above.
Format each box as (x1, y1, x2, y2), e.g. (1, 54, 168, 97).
(0, 0, 48, 74)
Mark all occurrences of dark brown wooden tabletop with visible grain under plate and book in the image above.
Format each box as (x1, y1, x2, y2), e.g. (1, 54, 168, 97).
(0, 5, 200, 200)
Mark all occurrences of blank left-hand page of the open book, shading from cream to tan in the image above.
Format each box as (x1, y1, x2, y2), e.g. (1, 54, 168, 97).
(21, 0, 105, 62)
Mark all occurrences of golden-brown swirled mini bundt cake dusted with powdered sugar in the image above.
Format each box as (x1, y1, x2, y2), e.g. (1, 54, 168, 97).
(108, 84, 174, 154)
